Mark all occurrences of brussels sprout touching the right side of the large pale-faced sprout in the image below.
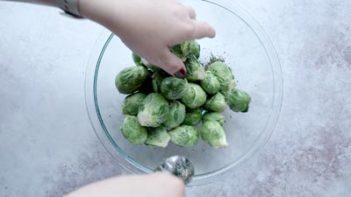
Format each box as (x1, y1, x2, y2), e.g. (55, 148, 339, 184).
(163, 101, 185, 129)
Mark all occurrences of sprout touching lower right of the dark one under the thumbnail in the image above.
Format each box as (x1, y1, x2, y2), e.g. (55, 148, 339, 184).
(181, 83, 207, 109)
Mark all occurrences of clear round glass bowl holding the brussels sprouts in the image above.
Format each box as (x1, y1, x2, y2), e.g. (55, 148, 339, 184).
(86, 0, 283, 185)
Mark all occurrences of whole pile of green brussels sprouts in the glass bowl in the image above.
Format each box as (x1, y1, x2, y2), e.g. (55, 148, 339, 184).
(115, 41, 251, 148)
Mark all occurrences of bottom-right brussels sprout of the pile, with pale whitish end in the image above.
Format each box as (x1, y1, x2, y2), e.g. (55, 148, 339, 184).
(200, 120, 228, 148)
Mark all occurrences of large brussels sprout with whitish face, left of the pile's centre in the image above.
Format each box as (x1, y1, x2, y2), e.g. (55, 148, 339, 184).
(138, 93, 169, 127)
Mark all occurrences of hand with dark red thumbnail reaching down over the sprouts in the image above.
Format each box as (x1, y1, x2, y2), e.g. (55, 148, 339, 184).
(79, 0, 215, 74)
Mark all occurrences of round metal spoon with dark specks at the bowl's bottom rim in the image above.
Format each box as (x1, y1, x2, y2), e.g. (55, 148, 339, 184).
(155, 155, 195, 184)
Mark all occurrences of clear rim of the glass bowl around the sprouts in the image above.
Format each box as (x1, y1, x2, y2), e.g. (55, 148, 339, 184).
(85, 0, 283, 185)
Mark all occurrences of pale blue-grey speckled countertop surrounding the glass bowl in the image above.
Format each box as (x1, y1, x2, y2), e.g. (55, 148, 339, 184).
(0, 0, 351, 197)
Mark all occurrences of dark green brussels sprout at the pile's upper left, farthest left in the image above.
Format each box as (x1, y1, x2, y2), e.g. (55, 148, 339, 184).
(115, 66, 149, 94)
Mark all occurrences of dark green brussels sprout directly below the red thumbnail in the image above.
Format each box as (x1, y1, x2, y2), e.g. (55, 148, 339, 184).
(160, 77, 188, 100)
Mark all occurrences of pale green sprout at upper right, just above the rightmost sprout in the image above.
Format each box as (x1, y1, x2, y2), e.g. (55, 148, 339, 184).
(207, 61, 236, 92)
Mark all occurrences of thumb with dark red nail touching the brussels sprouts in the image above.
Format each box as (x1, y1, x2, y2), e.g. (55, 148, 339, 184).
(160, 49, 186, 75)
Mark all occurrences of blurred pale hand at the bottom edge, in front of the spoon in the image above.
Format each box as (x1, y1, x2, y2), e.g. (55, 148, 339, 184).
(67, 173, 185, 197)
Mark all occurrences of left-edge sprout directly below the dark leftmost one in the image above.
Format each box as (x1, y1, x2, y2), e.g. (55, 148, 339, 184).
(122, 93, 146, 116)
